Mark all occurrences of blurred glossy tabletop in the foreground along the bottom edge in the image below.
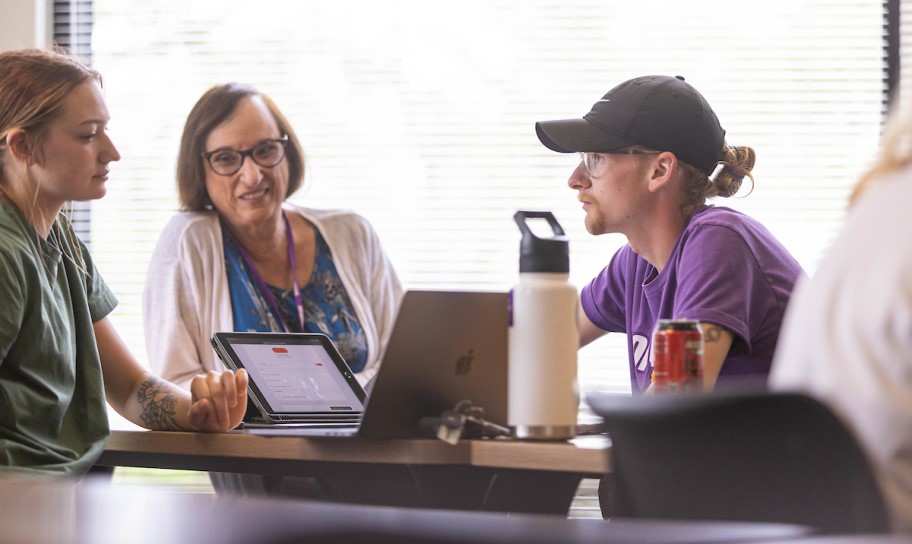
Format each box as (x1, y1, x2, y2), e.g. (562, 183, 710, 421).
(0, 478, 812, 544)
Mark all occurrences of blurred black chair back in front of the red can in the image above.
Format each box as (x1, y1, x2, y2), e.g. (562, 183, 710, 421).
(588, 392, 889, 534)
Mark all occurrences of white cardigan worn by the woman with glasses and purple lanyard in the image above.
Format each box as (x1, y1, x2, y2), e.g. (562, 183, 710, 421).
(143, 203, 402, 388)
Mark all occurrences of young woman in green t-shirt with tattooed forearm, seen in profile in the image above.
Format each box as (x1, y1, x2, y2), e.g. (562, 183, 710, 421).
(0, 50, 247, 475)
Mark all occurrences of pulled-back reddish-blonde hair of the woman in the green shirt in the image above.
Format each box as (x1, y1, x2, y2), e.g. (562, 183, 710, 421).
(0, 49, 101, 273)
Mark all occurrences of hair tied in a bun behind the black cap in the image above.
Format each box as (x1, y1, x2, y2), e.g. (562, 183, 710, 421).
(678, 143, 757, 217)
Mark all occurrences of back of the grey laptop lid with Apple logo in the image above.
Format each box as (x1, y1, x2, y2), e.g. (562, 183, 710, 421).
(359, 290, 507, 438)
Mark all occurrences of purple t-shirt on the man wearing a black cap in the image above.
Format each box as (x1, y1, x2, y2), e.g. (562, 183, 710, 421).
(581, 206, 804, 393)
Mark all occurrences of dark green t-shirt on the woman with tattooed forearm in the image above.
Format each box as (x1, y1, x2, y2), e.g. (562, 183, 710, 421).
(0, 195, 117, 474)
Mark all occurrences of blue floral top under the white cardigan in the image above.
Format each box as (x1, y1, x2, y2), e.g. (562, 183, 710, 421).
(222, 227, 367, 372)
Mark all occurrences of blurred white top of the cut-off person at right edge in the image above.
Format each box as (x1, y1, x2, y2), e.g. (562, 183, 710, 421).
(770, 167, 912, 533)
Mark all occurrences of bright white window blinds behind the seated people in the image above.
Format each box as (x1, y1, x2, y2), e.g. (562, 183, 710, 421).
(91, 0, 885, 400)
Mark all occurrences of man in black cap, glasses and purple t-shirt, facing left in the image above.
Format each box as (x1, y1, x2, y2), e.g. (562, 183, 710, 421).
(535, 76, 803, 393)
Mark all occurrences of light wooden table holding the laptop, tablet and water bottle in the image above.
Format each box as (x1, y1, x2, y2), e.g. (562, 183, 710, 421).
(98, 431, 609, 515)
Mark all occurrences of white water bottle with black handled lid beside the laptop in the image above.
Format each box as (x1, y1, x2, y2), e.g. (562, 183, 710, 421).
(507, 211, 579, 440)
